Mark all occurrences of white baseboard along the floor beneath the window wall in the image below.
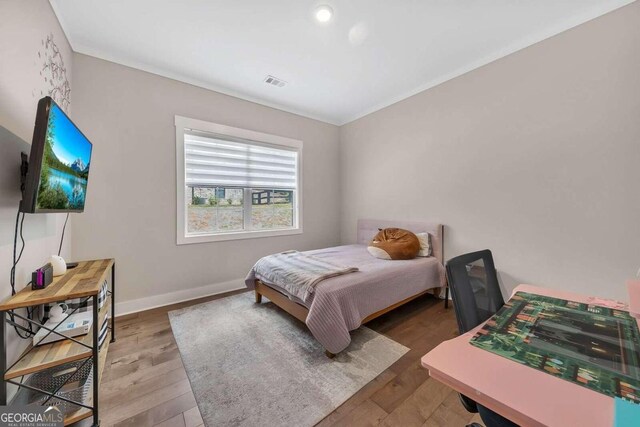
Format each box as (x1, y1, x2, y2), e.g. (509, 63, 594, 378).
(116, 279, 245, 316)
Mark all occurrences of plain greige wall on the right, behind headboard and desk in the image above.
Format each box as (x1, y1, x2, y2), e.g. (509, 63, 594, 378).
(341, 3, 640, 299)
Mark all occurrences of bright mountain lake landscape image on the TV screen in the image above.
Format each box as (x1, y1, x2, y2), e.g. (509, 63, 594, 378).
(36, 103, 92, 211)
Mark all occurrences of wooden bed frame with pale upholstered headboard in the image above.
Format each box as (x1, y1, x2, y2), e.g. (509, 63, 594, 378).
(255, 220, 449, 358)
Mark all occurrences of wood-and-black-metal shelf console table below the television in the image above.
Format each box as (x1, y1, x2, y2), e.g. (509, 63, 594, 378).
(0, 259, 116, 426)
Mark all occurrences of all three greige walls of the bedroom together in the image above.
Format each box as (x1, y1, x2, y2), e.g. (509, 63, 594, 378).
(0, 0, 640, 320)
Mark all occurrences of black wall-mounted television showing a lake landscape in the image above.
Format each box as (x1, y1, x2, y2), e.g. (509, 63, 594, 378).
(20, 96, 93, 213)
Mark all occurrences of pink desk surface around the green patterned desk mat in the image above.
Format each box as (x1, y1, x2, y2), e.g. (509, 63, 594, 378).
(422, 285, 636, 427)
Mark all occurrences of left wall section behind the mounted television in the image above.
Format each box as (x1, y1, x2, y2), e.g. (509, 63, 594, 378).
(0, 0, 72, 360)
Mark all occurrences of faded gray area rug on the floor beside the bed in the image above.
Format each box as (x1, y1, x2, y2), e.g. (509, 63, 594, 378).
(169, 293, 409, 427)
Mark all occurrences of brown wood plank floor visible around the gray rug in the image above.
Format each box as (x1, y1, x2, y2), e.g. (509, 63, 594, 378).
(100, 292, 479, 427)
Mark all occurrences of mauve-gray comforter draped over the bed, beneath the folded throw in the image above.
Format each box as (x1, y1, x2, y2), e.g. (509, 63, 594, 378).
(245, 245, 444, 353)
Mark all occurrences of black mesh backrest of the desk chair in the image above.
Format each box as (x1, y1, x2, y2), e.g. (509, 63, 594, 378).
(447, 249, 504, 334)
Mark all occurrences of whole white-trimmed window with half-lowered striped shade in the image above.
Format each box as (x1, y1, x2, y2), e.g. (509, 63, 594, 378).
(175, 116, 302, 244)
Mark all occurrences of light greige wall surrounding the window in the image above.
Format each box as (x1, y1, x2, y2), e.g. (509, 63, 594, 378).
(67, 54, 340, 311)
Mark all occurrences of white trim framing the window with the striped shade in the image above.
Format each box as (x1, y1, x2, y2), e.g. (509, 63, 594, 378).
(175, 116, 303, 245)
